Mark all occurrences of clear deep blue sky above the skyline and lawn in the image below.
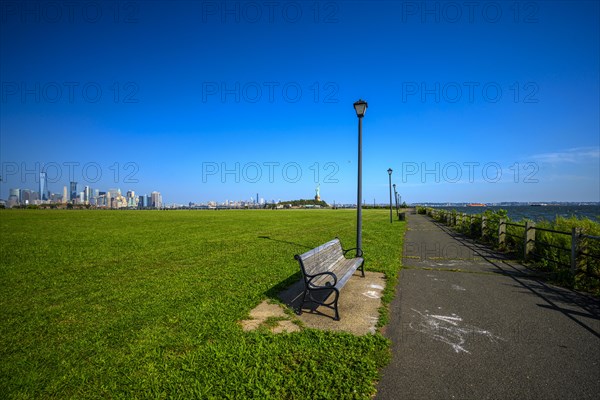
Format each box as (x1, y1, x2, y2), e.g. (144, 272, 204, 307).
(0, 0, 600, 204)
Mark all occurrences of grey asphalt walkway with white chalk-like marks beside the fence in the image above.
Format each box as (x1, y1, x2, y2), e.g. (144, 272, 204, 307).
(376, 214, 600, 400)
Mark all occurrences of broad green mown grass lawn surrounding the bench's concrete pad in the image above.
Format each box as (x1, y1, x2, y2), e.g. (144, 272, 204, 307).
(0, 210, 404, 399)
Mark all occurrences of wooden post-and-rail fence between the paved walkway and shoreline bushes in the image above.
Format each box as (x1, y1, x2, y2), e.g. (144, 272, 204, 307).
(426, 208, 600, 278)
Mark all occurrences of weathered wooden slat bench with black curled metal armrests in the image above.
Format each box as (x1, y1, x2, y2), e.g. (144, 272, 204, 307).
(294, 238, 365, 321)
